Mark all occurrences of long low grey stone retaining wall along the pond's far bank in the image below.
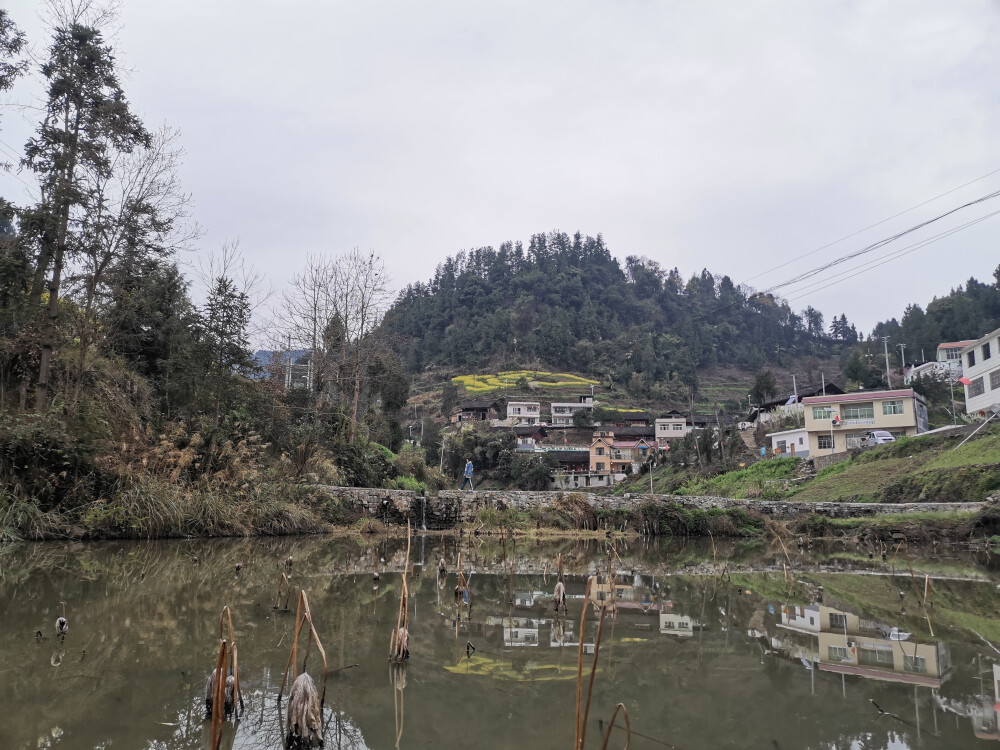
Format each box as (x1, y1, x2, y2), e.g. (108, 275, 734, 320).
(319, 485, 982, 529)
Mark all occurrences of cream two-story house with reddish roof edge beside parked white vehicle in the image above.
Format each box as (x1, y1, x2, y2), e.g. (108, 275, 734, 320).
(802, 388, 927, 456)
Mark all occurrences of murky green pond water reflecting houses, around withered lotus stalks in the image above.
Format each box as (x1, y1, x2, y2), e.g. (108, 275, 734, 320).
(0, 535, 1000, 750)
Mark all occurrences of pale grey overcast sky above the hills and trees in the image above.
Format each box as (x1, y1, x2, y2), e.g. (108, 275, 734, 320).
(0, 0, 1000, 342)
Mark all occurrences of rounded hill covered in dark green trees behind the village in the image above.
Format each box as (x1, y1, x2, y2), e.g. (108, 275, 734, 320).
(386, 233, 857, 386)
